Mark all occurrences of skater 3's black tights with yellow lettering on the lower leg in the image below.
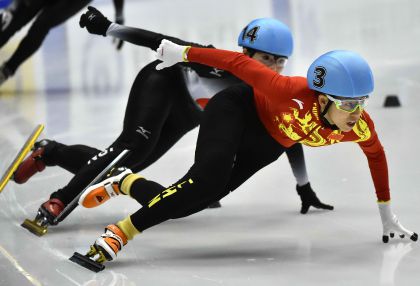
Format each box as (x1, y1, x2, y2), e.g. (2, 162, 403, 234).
(124, 85, 284, 231)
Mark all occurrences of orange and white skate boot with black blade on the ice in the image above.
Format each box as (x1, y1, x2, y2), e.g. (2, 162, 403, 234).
(70, 224, 127, 272)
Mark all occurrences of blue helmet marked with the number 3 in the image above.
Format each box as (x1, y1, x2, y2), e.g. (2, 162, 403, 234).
(307, 50, 374, 98)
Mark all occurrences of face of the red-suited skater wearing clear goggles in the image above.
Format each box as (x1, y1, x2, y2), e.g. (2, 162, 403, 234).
(318, 94, 367, 132)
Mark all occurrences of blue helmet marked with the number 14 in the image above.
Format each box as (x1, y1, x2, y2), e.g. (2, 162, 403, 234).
(238, 18, 293, 58)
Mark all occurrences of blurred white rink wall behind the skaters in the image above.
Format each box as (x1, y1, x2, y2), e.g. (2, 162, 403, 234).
(0, 0, 420, 104)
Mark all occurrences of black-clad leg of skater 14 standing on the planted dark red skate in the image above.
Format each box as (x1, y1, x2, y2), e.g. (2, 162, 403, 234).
(51, 62, 199, 204)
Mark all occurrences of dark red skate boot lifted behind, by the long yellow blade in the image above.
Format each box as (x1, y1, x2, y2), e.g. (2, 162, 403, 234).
(13, 139, 51, 184)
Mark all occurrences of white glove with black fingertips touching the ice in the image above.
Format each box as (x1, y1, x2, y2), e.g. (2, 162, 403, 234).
(378, 201, 418, 243)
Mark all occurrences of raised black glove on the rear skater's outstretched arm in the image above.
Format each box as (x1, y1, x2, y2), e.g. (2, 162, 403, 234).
(79, 6, 112, 37)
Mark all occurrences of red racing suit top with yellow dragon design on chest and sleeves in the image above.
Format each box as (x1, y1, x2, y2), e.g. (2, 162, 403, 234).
(187, 47, 390, 201)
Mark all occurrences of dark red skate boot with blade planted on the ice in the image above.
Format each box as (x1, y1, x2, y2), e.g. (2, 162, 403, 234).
(22, 198, 65, 236)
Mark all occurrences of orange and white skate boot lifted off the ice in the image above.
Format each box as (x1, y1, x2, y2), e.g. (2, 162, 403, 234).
(79, 167, 133, 208)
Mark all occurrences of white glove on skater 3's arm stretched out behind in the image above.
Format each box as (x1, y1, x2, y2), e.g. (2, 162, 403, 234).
(156, 40, 191, 70)
